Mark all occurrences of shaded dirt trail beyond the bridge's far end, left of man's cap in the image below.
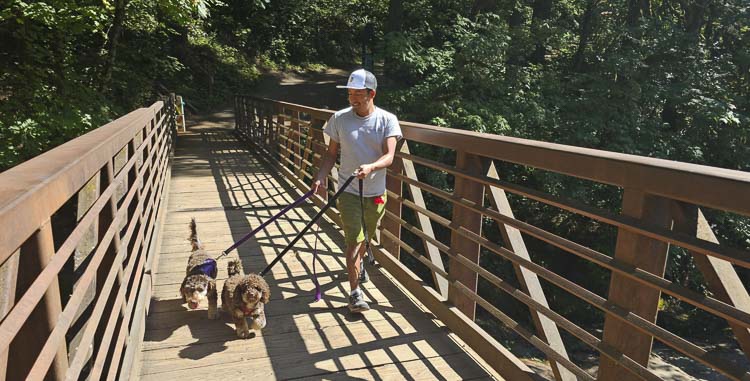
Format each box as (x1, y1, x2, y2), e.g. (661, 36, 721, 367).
(252, 69, 349, 110)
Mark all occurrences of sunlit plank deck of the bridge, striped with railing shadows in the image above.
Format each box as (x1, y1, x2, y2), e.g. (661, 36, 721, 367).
(137, 114, 500, 380)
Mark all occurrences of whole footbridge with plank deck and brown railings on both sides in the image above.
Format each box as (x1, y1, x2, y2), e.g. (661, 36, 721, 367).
(0, 97, 750, 380)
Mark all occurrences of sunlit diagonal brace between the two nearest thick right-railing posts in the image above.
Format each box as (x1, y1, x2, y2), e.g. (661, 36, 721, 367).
(487, 162, 576, 381)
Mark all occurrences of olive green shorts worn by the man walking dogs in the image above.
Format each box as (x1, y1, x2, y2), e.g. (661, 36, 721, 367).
(336, 192, 387, 246)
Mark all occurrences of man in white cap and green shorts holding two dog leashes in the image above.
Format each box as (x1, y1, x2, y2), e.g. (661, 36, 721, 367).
(313, 69, 401, 313)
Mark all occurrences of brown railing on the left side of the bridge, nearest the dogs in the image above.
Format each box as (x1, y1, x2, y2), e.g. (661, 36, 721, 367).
(0, 100, 175, 380)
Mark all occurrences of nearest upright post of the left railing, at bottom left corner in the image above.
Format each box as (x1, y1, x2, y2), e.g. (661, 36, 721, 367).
(7, 220, 68, 380)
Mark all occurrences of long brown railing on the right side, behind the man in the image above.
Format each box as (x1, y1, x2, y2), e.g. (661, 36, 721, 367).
(235, 96, 750, 380)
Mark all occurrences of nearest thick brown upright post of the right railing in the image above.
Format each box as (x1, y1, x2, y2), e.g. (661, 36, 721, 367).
(598, 188, 672, 381)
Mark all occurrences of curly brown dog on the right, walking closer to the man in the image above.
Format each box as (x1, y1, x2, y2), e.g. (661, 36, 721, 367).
(221, 259, 271, 339)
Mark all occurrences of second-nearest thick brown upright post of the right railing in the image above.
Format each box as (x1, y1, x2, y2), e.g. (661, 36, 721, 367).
(448, 151, 486, 321)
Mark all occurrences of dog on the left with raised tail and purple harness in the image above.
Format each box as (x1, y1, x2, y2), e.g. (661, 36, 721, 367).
(180, 218, 219, 320)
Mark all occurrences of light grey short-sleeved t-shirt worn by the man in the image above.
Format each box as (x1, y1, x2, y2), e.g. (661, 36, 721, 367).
(323, 107, 402, 197)
